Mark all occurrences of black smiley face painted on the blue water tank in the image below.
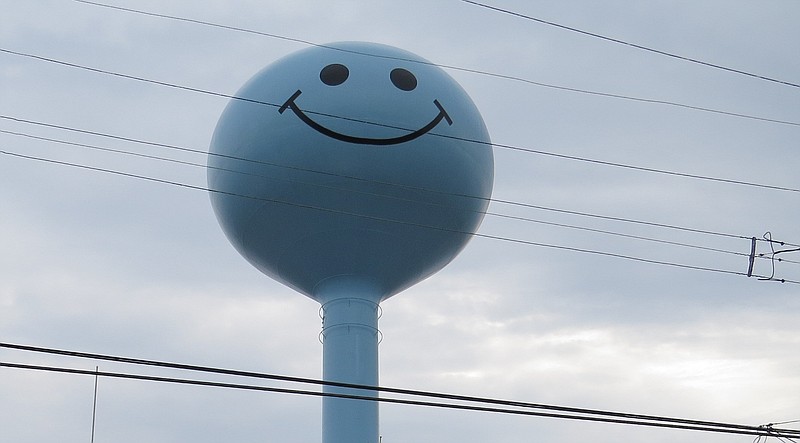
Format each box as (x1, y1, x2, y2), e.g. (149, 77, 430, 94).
(278, 63, 453, 146)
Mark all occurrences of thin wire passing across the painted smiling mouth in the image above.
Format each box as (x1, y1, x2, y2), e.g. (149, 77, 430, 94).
(0, 47, 800, 197)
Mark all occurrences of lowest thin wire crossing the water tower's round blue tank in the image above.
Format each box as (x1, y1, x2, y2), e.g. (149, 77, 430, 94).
(0, 150, 800, 284)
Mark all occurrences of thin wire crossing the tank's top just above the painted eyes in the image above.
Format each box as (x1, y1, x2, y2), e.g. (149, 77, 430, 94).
(73, 0, 800, 126)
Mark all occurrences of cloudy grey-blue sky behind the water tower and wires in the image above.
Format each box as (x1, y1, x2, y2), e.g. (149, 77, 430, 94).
(0, 0, 800, 443)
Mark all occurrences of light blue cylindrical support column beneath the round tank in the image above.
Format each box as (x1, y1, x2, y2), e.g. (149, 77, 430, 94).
(322, 298, 379, 443)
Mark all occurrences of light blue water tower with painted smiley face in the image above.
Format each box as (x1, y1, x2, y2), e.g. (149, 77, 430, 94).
(208, 42, 494, 443)
